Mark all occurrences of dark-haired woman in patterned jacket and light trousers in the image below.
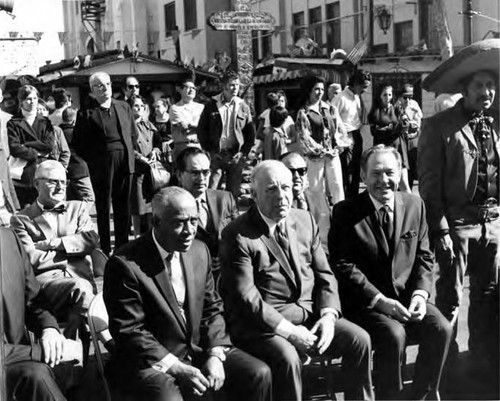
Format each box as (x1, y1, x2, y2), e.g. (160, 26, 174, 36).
(295, 76, 347, 205)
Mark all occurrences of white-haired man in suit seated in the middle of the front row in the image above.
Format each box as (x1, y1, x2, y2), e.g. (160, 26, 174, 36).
(221, 160, 373, 400)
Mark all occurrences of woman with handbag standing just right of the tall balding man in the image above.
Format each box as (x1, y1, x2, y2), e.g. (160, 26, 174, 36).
(127, 95, 161, 237)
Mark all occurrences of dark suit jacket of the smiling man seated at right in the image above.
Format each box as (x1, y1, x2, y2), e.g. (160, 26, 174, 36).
(328, 191, 434, 313)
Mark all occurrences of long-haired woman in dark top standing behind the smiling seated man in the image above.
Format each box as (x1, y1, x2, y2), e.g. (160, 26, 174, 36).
(368, 84, 411, 192)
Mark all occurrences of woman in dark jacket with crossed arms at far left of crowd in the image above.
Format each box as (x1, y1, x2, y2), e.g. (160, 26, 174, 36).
(7, 85, 54, 207)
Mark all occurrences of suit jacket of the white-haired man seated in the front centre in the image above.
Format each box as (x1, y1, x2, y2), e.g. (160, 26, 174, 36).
(220, 206, 340, 341)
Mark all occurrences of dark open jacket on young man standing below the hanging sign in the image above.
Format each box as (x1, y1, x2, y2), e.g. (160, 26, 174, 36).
(198, 98, 255, 154)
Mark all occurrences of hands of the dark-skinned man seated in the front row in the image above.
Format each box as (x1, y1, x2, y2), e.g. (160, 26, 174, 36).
(168, 356, 226, 396)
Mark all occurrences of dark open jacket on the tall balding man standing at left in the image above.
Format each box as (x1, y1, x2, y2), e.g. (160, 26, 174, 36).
(73, 99, 137, 173)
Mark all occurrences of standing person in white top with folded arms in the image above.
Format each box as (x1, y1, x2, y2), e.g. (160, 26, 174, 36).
(170, 78, 204, 160)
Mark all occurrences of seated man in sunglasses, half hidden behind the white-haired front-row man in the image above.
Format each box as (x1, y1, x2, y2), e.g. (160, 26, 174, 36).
(281, 152, 330, 256)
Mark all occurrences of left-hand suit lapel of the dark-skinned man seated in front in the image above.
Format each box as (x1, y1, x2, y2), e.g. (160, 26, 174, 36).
(144, 233, 187, 334)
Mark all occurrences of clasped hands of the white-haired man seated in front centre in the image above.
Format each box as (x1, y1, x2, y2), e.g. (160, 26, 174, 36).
(288, 313, 337, 355)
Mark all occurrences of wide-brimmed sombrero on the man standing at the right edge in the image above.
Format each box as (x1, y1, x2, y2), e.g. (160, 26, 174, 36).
(422, 39, 500, 93)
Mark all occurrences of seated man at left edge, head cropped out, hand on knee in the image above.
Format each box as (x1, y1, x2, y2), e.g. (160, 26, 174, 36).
(0, 227, 82, 401)
